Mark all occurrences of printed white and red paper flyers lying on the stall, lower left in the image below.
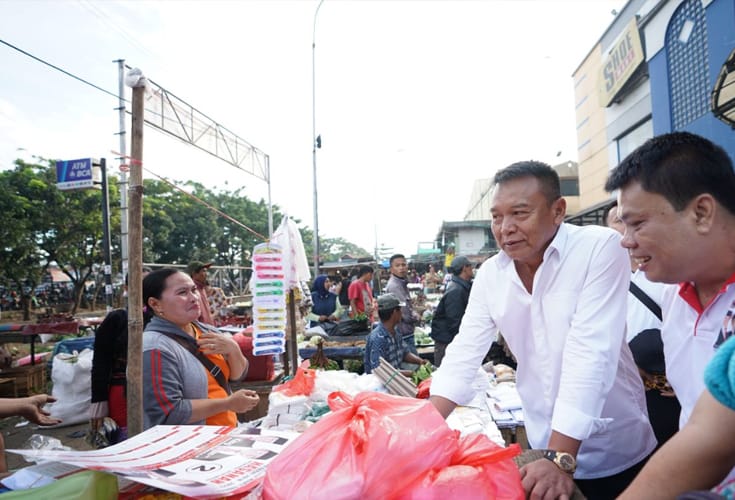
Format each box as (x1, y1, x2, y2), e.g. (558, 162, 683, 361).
(7, 425, 299, 498)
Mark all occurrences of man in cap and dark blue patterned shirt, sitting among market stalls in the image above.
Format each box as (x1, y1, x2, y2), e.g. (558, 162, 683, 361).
(365, 293, 426, 375)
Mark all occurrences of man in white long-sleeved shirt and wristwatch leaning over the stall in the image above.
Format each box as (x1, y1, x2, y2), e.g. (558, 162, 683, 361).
(431, 161, 656, 499)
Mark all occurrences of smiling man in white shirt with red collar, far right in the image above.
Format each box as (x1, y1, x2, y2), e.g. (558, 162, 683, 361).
(605, 132, 735, 498)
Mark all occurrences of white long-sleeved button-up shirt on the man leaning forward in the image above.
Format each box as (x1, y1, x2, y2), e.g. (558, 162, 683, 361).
(431, 224, 656, 479)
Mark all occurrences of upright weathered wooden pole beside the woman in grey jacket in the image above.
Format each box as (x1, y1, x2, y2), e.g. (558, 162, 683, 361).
(127, 75, 145, 437)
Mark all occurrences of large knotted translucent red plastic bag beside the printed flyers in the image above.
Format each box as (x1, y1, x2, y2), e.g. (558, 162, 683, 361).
(263, 392, 459, 500)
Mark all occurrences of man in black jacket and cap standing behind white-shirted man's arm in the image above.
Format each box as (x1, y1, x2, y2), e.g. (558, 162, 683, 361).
(430, 255, 474, 366)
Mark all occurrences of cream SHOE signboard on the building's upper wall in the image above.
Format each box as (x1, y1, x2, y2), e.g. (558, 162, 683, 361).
(598, 17, 645, 107)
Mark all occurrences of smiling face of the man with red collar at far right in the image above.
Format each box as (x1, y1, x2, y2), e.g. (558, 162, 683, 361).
(618, 182, 699, 283)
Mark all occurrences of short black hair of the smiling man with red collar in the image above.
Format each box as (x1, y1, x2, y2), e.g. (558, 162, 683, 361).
(605, 132, 735, 214)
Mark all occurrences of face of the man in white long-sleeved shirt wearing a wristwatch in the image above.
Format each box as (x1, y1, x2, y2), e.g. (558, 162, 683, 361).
(490, 176, 566, 268)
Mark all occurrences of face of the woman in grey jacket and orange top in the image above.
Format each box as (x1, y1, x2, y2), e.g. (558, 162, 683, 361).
(148, 272, 201, 328)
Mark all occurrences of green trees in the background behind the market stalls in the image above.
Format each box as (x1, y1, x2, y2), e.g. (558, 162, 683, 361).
(0, 158, 370, 306)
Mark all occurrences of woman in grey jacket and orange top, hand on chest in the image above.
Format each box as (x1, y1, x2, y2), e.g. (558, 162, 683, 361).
(143, 269, 258, 429)
